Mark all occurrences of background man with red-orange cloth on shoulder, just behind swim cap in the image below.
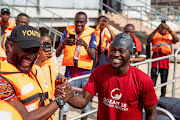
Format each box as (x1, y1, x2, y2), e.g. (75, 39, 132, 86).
(124, 24, 146, 63)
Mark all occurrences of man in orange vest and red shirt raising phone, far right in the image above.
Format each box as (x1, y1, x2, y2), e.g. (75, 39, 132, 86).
(147, 20, 179, 97)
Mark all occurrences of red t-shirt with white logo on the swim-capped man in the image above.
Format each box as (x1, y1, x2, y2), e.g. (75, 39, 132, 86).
(83, 64, 158, 120)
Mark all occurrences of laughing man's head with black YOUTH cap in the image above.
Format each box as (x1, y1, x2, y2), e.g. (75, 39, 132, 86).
(7, 25, 41, 73)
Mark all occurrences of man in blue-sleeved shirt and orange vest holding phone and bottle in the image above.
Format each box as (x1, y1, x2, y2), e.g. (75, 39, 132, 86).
(56, 12, 96, 120)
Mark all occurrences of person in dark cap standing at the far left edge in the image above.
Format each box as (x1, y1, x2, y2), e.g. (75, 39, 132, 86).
(0, 8, 15, 38)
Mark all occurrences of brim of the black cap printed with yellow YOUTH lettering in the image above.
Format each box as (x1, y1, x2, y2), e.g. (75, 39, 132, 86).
(17, 40, 41, 48)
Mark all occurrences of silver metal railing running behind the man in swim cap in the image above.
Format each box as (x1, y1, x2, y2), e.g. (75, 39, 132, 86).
(59, 49, 180, 120)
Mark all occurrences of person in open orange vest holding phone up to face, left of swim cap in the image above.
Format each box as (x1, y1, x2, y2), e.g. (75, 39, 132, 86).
(94, 16, 115, 67)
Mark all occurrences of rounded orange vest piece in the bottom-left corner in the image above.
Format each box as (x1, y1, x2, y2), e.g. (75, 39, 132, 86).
(0, 101, 23, 120)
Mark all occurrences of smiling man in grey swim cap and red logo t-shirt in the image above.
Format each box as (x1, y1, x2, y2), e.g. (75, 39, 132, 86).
(60, 33, 158, 120)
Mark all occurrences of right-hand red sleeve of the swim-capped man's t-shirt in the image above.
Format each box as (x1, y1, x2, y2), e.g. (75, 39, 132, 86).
(141, 76, 158, 107)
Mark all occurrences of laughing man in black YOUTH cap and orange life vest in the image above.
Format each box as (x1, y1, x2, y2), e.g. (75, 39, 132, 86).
(0, 25, 66, 120)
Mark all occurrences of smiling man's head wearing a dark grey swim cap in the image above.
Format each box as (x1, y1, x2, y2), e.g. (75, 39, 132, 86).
(108, 33, 133, 69)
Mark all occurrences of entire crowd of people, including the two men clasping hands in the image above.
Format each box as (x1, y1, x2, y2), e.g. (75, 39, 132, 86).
(0, 8, 179, 120)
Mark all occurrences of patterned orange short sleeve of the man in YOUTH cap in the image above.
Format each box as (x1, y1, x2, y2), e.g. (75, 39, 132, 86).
(0, 78, 16, 102)
